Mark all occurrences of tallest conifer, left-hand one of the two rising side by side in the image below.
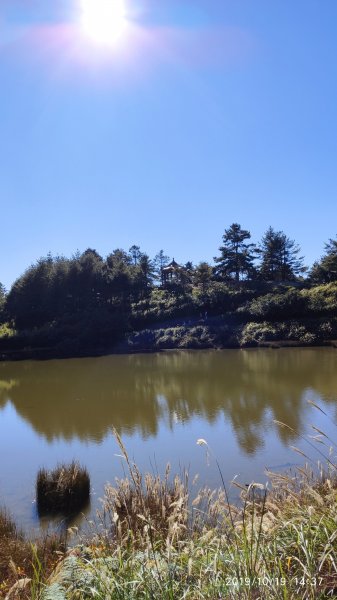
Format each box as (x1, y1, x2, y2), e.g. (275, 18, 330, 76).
(214, 223, 255, 282)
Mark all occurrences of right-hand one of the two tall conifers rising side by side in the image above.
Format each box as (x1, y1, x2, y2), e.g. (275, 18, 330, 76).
(258, 227, 306, 281)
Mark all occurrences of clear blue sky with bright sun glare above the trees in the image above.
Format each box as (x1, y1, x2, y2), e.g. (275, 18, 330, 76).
(0, 0, 337, 289)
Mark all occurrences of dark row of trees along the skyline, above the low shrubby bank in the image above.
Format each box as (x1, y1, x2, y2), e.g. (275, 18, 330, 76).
(0, 223, 337, 331)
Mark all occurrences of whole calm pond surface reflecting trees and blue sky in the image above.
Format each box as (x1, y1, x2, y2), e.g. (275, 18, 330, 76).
(0, 348, 337, 529)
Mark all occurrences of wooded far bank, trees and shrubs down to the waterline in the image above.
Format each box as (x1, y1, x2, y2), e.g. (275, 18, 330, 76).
(0, 223, 337, 359)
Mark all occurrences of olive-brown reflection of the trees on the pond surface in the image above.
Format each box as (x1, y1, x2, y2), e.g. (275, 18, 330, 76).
(0, 348, 337, 454)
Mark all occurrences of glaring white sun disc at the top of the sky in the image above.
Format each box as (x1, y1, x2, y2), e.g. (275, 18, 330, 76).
(81, 0, 127, 44)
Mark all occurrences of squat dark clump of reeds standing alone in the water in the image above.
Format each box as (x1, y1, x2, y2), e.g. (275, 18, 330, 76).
(36, 462, 90, 515)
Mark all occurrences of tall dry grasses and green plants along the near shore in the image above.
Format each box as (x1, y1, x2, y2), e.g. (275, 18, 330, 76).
(0, 432, 337, 600)
